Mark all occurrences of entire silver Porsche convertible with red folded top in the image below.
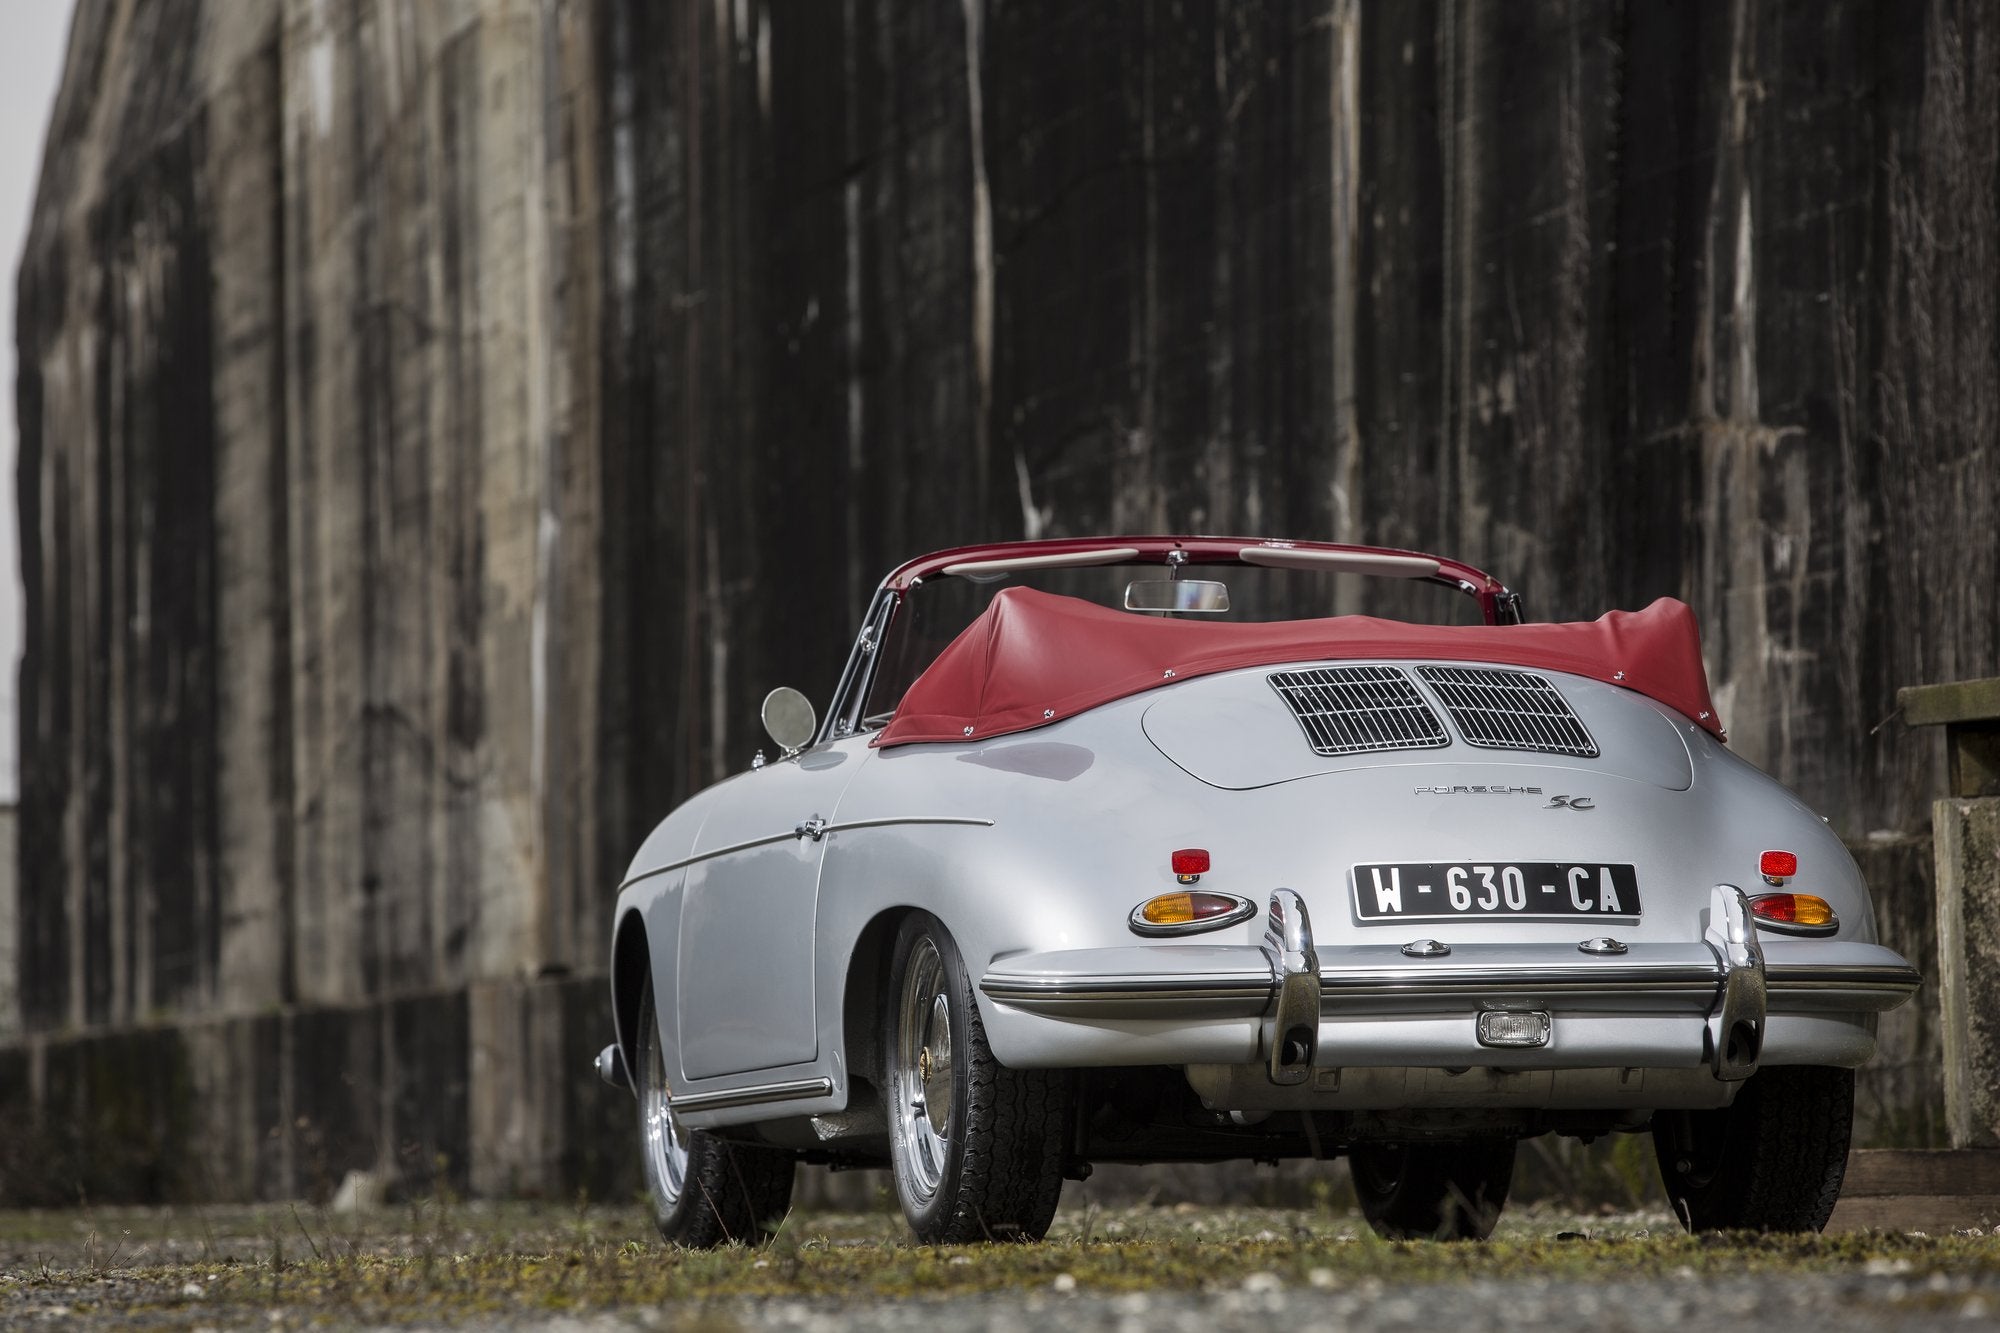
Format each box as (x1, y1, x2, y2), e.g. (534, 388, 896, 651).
(598, 536, 1920, 1245)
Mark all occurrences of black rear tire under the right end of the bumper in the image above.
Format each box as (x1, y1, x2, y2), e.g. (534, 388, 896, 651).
(1652, 1065, 1854, 1231)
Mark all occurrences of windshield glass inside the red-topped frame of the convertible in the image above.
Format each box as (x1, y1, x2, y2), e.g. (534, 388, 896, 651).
(850, 560, 1484, 729)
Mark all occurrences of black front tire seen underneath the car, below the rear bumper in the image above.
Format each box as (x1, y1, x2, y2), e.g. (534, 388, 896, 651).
(1348, 1139, 1514, 1241)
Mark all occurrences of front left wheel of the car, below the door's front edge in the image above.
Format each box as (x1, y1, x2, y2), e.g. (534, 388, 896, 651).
(634, 983, 798, 1249)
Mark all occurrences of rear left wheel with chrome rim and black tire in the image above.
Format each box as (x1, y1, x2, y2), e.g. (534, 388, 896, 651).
(882, 913, 1068, 1245)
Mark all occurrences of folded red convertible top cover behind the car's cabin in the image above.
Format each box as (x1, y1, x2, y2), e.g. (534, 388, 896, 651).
(874, 588, 1722, 747)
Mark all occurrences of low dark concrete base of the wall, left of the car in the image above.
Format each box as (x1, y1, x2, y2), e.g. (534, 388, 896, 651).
(0, 964, 638, 1205)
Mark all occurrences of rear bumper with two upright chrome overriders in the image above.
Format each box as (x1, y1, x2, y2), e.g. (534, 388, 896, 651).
(980, 885, 1922, 1091)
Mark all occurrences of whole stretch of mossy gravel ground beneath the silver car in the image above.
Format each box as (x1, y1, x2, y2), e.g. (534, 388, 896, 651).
(0, 1205, 2000, 1333)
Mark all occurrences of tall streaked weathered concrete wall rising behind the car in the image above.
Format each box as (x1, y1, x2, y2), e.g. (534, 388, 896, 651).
(16, 0, 2000, 1183)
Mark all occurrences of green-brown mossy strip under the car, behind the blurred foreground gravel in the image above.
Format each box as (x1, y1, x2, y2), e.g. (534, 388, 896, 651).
(0, 1205, 2000, 1325)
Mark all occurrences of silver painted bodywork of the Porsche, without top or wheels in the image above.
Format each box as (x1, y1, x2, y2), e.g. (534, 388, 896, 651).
(618, 640, 1916, 1127)
